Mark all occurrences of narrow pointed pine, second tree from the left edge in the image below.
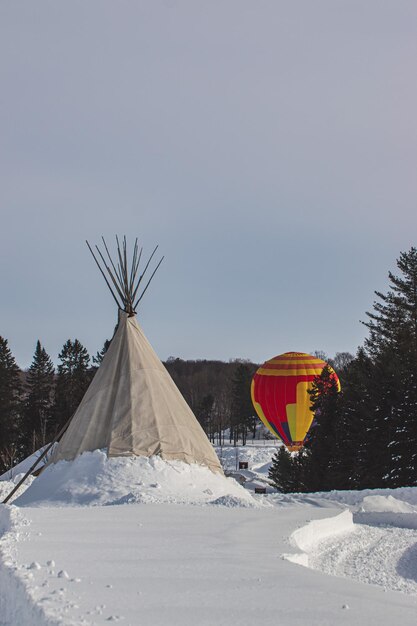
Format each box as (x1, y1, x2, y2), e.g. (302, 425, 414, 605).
(22, 340, 55, 454)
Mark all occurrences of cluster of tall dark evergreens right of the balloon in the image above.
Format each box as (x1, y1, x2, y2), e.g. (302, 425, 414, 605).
(269, 247, 417, 492)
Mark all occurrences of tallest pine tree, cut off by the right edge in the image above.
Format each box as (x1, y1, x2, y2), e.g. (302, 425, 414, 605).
(365, 247, 417, 487)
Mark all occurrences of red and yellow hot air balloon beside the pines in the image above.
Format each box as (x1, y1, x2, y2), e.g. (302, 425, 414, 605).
(251, 352, 340, 452)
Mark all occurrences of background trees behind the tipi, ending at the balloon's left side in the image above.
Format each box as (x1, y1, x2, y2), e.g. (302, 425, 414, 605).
(0, 337, 258, 473)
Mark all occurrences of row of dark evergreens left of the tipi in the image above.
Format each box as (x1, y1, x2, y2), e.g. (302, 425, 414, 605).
(0, 337, 95, 471)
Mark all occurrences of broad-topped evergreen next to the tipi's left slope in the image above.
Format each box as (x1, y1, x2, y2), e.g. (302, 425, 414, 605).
(53, 339, 92, 434)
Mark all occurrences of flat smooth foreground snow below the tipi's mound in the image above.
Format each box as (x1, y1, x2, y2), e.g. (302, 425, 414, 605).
(0, 504, 417, 626)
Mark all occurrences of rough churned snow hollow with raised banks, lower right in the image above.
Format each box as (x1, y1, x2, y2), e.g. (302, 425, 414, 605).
(283, 494, 417, 595)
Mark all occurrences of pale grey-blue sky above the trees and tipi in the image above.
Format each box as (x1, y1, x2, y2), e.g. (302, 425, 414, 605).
(0, 0, 417, 367)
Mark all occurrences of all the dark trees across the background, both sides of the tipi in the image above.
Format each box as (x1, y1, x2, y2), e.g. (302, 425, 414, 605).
(0, 247, 417, 491)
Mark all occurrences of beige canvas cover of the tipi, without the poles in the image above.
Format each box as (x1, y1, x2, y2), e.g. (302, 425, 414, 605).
(52, 311, 222, 472)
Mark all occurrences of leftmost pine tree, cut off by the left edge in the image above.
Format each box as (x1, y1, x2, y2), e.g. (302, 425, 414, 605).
(0, 337, 22, 472)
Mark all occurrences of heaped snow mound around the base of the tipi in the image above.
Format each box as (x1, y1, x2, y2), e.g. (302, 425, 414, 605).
(14, 450, 261, 507)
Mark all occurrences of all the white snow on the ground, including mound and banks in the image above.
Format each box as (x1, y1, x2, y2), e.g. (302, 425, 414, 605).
(0, 445, 417, 626)
